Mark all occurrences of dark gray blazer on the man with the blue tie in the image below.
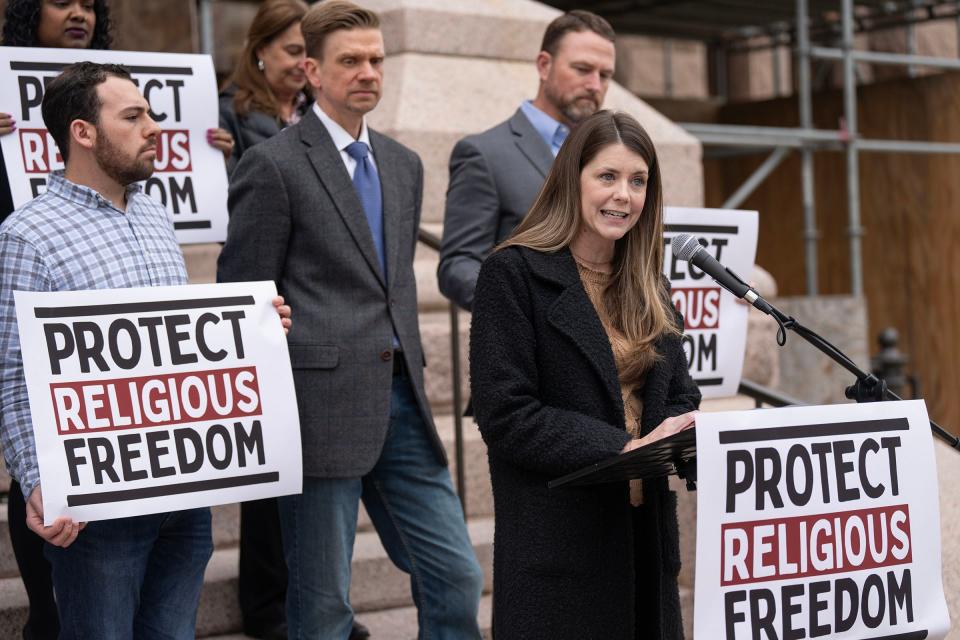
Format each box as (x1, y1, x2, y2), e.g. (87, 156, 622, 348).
(217, 111, 446, 477)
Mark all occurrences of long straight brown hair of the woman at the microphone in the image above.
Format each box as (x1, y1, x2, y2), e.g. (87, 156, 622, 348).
(498, 110, 679, 383)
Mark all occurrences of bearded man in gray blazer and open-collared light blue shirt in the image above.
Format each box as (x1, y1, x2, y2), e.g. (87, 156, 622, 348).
(437, 10, 615, 310)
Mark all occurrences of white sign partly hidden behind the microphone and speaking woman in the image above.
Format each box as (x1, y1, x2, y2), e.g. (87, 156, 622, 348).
(663, 207, 758, 398)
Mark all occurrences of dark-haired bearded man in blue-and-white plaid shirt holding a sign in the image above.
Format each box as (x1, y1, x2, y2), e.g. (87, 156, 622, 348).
(0, 62, 290, 640)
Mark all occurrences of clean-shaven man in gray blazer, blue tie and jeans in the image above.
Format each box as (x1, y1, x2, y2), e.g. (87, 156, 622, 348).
(219, 0, 483, 640)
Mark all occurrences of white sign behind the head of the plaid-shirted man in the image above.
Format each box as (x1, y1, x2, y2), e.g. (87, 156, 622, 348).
(0, 47, 227, 243)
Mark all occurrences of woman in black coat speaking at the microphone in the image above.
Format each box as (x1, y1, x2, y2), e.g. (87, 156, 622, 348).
(470, 111, 700, 640)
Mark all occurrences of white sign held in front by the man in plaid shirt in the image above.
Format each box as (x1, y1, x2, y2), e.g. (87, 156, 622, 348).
(14, 282, 303, 524)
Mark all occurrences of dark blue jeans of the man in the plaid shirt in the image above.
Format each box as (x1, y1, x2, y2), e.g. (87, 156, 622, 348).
(44, 508, 213, 640)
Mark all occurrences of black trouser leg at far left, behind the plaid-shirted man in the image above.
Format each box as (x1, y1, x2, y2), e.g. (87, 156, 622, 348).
(7, 480, 60, 640)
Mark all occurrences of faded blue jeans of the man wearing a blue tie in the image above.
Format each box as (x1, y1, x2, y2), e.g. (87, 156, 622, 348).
(279, 374, 483, 640)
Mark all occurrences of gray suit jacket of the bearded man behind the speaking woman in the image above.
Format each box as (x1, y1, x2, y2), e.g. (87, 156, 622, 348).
(437, 109, 553, 309)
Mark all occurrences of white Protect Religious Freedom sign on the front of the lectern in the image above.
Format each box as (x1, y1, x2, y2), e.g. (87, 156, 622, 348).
(694, 400, 950, 640)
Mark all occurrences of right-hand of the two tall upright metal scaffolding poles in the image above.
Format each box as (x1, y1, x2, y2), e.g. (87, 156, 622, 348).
(842, 0, 863, 296)
